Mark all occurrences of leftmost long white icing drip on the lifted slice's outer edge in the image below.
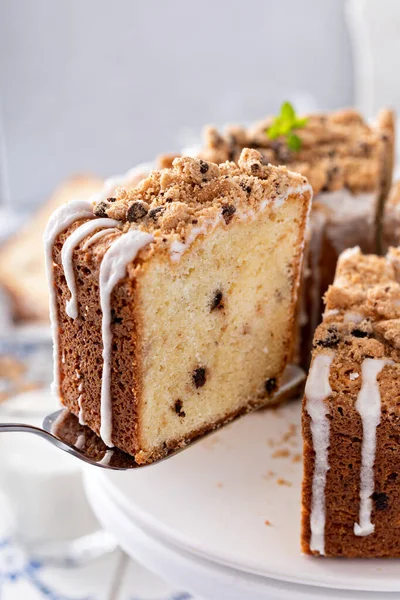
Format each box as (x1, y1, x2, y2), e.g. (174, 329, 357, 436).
(43, 200, 94, 396)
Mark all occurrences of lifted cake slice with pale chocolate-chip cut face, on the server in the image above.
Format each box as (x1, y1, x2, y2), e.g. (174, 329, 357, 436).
(45, 149, 312, 463)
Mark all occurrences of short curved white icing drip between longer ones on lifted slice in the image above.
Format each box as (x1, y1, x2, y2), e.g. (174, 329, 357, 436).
(61, 219, 118, 319)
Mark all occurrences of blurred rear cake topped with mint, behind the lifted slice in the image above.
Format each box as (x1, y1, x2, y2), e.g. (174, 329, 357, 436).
(196, 109, 394, 366)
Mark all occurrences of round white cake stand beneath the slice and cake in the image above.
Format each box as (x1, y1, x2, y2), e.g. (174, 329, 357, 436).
(83, 402, 400, 592)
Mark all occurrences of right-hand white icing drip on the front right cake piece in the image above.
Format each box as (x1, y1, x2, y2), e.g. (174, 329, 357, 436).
(354, 358, 393, 536)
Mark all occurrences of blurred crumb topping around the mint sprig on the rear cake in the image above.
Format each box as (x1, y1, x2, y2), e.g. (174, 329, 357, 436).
(199, 109, 394, 195)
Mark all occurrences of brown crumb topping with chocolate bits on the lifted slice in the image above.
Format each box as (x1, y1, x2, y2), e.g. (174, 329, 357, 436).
(94, 148, 311, 252)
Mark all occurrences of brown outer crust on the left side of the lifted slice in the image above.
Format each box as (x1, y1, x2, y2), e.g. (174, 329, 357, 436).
(53, 220, 145, 455)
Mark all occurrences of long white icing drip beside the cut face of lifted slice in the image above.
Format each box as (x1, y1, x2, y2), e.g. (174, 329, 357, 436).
(99, 230, 154, 446)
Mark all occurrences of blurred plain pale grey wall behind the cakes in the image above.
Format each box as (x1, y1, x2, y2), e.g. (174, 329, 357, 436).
(0, 0, 353, 206)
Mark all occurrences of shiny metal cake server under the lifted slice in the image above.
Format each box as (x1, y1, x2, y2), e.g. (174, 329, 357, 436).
(0, 365, 305, 471)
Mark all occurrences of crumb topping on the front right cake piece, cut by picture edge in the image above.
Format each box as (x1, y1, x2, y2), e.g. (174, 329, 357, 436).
(314, 248, 400, 366)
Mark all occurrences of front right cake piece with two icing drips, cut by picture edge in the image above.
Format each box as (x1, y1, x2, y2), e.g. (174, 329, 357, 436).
(302, 248, 400, 557)
